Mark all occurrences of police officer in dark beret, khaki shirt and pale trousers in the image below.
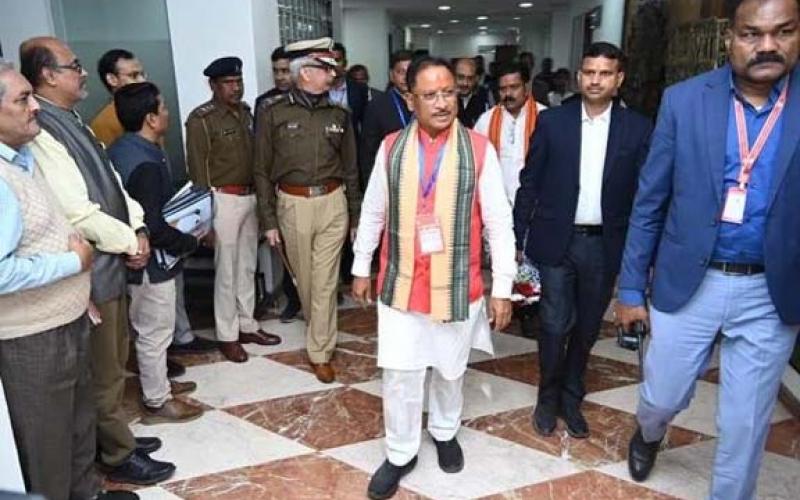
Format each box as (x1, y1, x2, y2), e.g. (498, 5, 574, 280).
(186, 57, 281, 363)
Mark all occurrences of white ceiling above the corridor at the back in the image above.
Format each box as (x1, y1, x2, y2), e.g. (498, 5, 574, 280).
(342, 0, 570, 34)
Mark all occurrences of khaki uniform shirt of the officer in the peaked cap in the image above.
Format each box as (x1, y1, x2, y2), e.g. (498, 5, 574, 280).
(255, 91, 361, 230)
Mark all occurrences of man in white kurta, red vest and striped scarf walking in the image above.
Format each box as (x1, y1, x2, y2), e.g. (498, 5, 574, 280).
(353, 58, 516, 499)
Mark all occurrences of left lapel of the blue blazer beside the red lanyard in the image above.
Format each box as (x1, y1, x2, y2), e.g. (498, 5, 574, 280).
(690, 71, 731, 203)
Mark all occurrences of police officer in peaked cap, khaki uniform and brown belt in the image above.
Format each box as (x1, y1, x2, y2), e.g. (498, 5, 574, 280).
(255, 38, 361, 383)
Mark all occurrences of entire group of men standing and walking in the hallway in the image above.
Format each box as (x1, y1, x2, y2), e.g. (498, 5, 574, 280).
(0, 0, 800, 500)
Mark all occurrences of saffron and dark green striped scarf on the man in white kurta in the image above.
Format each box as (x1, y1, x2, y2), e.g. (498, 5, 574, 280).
(381, 120, 476, 322)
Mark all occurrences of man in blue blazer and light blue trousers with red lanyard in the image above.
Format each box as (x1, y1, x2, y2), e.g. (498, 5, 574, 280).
(616, 0, 800, 500)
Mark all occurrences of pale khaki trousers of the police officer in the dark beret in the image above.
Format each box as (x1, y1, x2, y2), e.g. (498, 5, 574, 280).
(214, 191, 259, 342)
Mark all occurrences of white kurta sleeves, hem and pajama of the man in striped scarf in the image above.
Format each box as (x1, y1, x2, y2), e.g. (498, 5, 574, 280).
(353, 139, 516, 465)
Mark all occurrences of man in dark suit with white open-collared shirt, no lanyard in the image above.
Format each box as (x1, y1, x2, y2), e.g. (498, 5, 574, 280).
(514, 42, 652, 438)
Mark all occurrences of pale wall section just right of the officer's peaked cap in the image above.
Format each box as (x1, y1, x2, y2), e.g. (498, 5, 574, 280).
(340, 9, 392, 89)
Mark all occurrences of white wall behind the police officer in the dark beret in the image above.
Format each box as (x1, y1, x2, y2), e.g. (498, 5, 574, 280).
(167, 0, 278, 141)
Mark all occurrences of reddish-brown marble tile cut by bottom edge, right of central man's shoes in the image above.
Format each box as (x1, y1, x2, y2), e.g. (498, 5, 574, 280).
(481, 471, 676, 500)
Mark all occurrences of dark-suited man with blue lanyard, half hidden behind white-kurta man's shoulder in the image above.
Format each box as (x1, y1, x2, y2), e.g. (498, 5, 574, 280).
(358, 50, 413, 189)
